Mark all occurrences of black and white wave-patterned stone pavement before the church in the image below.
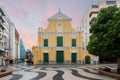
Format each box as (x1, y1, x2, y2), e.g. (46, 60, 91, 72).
(0, 66, 115, 80)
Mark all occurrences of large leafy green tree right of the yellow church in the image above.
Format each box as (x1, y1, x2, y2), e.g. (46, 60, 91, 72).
(87, 6, 120, 64)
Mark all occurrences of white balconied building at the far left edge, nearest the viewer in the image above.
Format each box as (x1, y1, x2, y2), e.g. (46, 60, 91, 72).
(0, 6, 10, 65)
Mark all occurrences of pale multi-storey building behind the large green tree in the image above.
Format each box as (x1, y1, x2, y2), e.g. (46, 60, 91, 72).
(80, 0, 120, 63)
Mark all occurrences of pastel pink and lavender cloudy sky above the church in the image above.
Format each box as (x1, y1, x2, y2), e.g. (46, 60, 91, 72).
(0, 0, 100, 49)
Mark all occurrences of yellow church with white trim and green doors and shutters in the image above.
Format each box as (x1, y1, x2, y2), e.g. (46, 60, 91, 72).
(32, 10, 93, 64)
